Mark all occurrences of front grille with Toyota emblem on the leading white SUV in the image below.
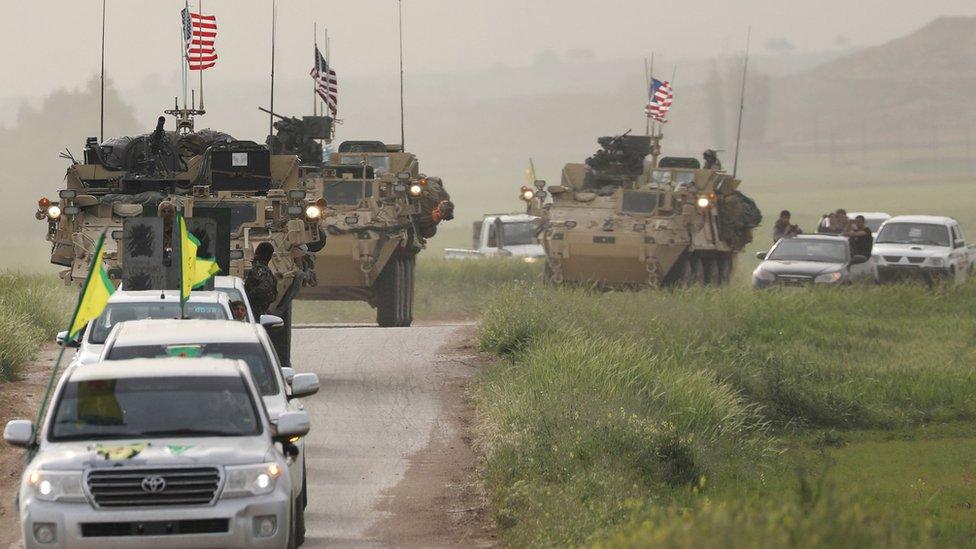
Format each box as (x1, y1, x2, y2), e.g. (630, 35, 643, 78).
(87, 467, 220, 507)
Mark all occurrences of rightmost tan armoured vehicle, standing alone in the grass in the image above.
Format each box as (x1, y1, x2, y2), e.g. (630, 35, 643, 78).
(521, 134, 762, 288)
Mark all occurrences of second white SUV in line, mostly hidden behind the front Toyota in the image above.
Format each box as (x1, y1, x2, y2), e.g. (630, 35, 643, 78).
(100, 320, 319, 544)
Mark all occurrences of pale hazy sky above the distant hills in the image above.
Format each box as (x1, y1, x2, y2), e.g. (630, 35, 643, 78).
(0, 0, 976, 101)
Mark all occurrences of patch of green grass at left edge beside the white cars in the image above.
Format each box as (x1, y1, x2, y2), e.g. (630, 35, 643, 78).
(0, 271, 72, 381)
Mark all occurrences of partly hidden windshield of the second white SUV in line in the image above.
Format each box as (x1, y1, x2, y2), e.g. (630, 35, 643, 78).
(105, 342, 278, 396)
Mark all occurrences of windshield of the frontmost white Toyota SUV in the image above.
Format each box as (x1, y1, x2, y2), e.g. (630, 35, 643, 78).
(49, 376, 261, 441)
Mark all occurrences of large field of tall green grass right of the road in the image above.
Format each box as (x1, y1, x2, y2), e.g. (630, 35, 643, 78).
(477, 284, 976, 547)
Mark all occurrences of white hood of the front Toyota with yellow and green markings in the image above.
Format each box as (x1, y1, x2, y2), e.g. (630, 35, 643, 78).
(31, 436, 273, 470)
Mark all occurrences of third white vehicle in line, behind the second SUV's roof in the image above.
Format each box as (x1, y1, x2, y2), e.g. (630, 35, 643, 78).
(57, 290, 233, 364)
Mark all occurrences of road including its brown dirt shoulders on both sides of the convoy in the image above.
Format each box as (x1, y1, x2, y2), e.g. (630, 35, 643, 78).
(0, 325, 496, 548)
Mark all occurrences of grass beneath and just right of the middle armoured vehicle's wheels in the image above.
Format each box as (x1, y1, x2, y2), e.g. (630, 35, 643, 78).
(295, 254, 542, 323)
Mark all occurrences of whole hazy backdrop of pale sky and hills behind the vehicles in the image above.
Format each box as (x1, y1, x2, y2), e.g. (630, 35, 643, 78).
(0, 0, 976, 262)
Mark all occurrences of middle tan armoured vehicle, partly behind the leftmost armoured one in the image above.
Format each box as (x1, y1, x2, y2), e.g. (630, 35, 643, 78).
(269, 117, 454, 326)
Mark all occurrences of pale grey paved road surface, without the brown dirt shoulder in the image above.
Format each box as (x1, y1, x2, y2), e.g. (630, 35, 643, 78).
(293, 326, 470, 547)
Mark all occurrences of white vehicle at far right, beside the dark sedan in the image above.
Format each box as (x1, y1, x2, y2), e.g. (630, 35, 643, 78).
(872, 215, 976, 284)
